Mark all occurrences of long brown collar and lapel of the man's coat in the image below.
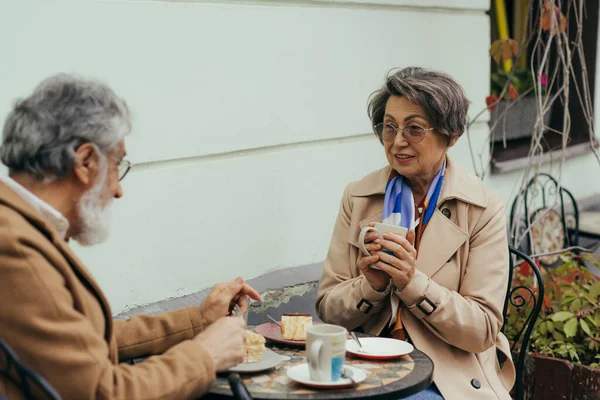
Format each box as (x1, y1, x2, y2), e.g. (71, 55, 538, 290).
(0, 181, 112, 342)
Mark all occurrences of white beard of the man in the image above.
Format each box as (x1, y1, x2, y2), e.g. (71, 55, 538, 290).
(73, 165, 112, 246)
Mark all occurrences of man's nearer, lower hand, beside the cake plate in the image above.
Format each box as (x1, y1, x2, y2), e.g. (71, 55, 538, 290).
(194, 317, 247, 372)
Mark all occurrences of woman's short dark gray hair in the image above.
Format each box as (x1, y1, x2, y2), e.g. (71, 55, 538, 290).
(368, 67, 469, 142)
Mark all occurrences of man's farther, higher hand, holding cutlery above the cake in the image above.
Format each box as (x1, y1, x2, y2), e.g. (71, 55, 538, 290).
(199, 277, 260, 326)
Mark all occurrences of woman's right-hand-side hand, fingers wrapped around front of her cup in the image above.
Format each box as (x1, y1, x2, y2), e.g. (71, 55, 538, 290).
(374, 230, 417, 290)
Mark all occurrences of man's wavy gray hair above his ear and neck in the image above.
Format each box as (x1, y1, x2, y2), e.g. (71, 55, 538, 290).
(0, 74, 131, 179)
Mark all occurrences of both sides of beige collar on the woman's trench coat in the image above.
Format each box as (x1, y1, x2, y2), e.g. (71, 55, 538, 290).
(350, 157, 487, 208)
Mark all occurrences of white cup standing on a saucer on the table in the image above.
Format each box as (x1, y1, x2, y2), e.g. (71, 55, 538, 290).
(306, 324, 348, 382)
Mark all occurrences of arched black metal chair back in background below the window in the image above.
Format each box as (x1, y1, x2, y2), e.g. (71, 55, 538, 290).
(510, 173, 580, 266)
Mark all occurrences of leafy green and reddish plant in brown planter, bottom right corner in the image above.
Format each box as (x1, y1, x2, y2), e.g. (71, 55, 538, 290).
(505, 253, 600, 400)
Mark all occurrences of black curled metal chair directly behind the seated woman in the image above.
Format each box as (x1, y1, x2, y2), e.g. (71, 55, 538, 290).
(502, 247, 544, 400)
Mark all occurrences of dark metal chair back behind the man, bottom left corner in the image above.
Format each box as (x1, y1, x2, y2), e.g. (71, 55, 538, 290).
(0, 339, 60, 400)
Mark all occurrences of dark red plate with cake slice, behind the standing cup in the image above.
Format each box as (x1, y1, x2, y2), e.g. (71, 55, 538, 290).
(255, 314, 319, 346)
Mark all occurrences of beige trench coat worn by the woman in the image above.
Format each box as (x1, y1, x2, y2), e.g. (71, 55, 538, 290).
(317, 159, 515, 400)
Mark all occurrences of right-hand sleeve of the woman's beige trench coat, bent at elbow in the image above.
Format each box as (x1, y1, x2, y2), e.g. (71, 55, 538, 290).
(397, 194, 509, 353)
